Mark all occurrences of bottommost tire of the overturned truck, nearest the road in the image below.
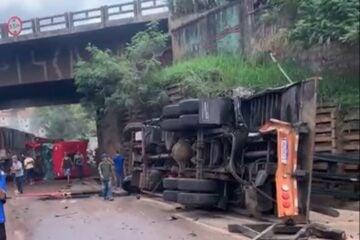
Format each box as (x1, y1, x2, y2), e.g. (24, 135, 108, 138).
(177, 192, 220, 207)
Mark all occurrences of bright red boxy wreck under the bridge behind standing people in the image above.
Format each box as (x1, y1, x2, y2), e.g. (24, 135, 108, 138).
(52, 140, 90, 178)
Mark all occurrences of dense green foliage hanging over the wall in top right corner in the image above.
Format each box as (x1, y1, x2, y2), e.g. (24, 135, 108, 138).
(263, 0, 360, 46)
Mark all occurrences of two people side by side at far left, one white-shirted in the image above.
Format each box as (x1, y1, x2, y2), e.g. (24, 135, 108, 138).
(10, 155, 35, 194)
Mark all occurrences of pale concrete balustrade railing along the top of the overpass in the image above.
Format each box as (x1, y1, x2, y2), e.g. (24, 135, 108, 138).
(0, 0, 168, 45)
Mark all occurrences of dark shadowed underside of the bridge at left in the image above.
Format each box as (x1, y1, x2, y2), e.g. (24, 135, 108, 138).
(0, 79, 81, 110)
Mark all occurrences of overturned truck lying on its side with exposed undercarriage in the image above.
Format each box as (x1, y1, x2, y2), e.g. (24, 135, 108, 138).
(125, 80, 317, 220)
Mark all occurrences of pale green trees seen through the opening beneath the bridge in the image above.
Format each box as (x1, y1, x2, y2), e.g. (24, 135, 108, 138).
(34, 104, 96, 139)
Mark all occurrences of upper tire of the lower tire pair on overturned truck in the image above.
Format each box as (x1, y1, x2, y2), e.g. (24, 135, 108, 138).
(177, 178, 219, 192)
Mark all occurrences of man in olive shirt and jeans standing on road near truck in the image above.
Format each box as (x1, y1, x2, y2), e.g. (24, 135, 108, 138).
(98, 154, 115, 201)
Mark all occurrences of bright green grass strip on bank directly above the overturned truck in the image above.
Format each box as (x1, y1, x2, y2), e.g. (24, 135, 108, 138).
(158, 55, 305, 96)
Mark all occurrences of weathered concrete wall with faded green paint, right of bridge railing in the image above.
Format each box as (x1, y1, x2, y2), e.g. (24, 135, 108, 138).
(169, 3, 242, 59)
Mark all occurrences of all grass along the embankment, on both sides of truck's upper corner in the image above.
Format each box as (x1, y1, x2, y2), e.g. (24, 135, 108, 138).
(157, 55, 359, 107)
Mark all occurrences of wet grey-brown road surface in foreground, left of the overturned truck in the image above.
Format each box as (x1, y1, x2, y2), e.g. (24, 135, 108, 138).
(6, 182, 242, 240)
